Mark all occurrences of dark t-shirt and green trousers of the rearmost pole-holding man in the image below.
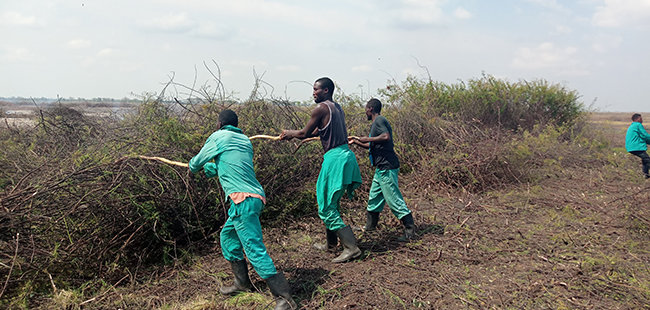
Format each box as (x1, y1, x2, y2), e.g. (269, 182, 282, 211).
(367, 115, 411, 219)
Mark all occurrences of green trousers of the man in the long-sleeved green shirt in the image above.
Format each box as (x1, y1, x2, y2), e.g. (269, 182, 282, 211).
(221, 197, 277, 279)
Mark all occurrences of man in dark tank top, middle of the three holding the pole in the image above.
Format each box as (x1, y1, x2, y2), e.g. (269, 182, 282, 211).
(281, 77, 361, 263)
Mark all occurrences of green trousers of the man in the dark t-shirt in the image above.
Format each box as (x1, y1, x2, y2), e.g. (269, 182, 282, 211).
(368, 168, 411, 219)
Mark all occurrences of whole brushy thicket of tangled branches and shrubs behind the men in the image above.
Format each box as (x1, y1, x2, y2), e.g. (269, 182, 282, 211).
(0, 76, 599, 303)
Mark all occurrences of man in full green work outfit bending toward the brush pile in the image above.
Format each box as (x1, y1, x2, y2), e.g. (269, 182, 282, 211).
(189, 110, 297, 310)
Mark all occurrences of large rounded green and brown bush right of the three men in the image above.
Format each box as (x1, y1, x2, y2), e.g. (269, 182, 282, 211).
(364, 75, 585, 191)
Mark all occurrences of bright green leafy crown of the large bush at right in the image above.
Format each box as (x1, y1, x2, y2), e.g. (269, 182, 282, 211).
(381, 74, 584, 130)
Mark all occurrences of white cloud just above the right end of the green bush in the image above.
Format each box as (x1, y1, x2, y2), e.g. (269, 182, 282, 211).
(511, 42, 584, 74)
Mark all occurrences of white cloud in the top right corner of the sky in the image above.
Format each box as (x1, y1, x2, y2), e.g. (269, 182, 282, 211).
(591, 0, 650, 28)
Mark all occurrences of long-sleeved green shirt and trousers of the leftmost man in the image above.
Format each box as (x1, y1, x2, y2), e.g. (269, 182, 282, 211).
(189, 125, 277, 279)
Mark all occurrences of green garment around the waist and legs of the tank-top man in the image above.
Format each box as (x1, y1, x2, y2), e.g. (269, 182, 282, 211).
(316, 144, 361, 231)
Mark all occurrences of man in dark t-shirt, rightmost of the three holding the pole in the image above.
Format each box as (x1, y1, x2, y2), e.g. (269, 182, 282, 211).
(350, 99, 415, 241)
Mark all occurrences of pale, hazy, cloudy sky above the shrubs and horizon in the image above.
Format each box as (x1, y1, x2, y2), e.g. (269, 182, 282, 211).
(0, 0, 650, 112)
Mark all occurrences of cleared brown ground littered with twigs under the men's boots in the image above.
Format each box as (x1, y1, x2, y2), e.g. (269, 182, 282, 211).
(38, 113, 650, 309)
